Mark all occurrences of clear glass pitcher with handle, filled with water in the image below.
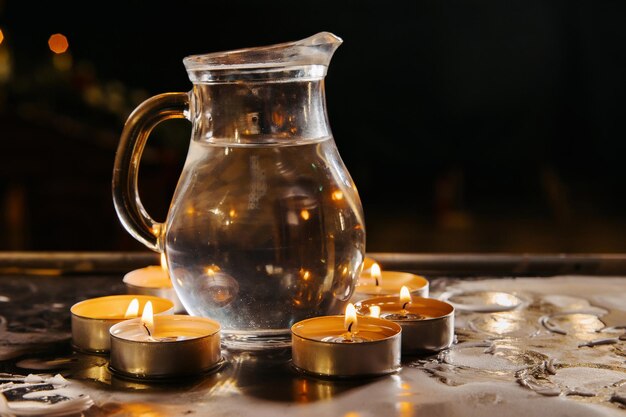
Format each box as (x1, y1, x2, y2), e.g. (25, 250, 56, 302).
(113, 32, 365, 349)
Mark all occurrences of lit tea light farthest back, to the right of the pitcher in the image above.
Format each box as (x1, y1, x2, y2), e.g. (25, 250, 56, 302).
(352, 263, 428, 302)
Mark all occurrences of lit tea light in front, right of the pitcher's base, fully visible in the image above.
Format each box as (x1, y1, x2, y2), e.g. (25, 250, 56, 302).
(291, 304, 402, 377)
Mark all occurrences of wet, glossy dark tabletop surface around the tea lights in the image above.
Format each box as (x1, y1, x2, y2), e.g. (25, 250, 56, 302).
(0, 275, 626, 417)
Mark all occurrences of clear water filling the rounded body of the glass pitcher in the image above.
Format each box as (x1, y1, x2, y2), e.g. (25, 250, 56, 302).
(165, 137, 365, 344)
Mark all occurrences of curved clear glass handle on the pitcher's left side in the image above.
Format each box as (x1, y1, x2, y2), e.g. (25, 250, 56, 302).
(113, 93, 189, 252)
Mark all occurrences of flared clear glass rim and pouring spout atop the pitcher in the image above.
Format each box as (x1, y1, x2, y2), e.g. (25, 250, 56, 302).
(183, 32, 343, 83)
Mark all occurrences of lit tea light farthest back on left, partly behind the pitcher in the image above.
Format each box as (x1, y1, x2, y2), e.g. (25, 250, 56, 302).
(122, 253, 186, 313)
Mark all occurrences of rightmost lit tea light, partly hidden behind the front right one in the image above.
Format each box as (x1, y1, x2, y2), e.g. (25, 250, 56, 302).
(356, 288, 454, 354)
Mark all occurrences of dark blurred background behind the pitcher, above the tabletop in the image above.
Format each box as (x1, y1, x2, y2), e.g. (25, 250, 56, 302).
(0, 0, 626, 252)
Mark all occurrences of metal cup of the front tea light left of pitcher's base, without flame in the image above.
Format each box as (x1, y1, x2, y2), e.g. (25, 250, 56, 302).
(109, 315, 222, 380)
